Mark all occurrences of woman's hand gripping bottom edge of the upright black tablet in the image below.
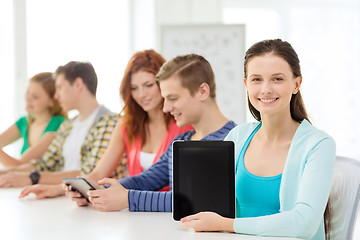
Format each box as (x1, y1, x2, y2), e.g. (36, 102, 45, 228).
(180, 212, 234, 232)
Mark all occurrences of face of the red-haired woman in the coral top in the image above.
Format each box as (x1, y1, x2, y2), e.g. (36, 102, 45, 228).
(130, 71, 163, 112)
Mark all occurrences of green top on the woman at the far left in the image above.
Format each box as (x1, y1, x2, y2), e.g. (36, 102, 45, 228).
(16, 116, 65, 154)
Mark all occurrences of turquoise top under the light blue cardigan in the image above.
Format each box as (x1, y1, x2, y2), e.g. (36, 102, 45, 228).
(236, 124, 282, 218)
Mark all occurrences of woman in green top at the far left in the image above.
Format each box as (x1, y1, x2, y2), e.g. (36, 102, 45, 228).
(0, 72, 67, 167)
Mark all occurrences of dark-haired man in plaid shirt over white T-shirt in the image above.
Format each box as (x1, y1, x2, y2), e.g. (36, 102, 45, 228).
(0, 61, 126, 187)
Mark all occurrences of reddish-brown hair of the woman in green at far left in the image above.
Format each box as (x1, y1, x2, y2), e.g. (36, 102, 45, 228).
(28, 72, 67, 124)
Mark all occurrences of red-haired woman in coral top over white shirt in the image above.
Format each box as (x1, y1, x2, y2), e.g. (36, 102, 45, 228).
(20, 50, 192, 199)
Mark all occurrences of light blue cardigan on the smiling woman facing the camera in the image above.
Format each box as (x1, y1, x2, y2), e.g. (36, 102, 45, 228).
(225, 120, 336, 240)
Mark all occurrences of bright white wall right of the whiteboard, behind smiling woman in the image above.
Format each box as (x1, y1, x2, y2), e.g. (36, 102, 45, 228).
(223, 0, 360, 160)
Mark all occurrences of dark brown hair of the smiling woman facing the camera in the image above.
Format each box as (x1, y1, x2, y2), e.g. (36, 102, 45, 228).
(244, 39, 310, 122)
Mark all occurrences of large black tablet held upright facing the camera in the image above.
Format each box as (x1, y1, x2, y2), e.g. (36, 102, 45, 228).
(173, 141, 235, 221)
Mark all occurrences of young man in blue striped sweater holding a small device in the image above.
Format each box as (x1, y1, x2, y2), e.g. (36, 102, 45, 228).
(64, 54, 235, 212)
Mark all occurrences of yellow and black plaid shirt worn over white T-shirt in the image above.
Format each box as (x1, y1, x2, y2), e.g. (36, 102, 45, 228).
(30, 106, 127, 179)
